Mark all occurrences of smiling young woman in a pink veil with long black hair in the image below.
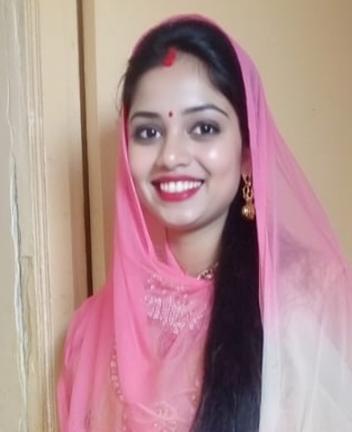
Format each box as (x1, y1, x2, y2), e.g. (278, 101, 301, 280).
(59, 16, 352, 432)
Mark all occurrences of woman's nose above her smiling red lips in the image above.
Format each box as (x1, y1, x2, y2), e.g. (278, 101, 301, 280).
(156, 133, 192, 170)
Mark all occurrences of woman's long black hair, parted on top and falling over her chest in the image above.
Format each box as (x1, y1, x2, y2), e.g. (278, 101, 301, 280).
(122, 17, 263, 432)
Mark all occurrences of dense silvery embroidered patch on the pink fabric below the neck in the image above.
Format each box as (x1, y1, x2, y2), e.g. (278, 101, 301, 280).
(145, 274, 207, 335)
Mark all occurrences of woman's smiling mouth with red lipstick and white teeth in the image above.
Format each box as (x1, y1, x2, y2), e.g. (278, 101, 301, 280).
(152, 176, 204, 202)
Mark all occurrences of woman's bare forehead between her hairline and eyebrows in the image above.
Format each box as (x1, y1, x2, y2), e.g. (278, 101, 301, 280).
(131, 52, 229, 111)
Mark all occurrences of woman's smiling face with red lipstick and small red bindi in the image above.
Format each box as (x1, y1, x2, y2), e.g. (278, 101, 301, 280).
(128, 52, 246, 235)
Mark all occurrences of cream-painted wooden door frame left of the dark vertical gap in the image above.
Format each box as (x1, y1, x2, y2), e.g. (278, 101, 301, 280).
(0, 0, 87, 432)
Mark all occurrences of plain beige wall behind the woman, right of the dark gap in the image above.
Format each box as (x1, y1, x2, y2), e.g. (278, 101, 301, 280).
(85, 0, 352, 289)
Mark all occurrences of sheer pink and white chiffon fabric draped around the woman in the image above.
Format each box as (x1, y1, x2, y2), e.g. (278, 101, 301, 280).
(58, 17, 352, 432)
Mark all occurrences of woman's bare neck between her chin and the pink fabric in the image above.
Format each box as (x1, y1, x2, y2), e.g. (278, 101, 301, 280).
(167, 217, 226, 276)
